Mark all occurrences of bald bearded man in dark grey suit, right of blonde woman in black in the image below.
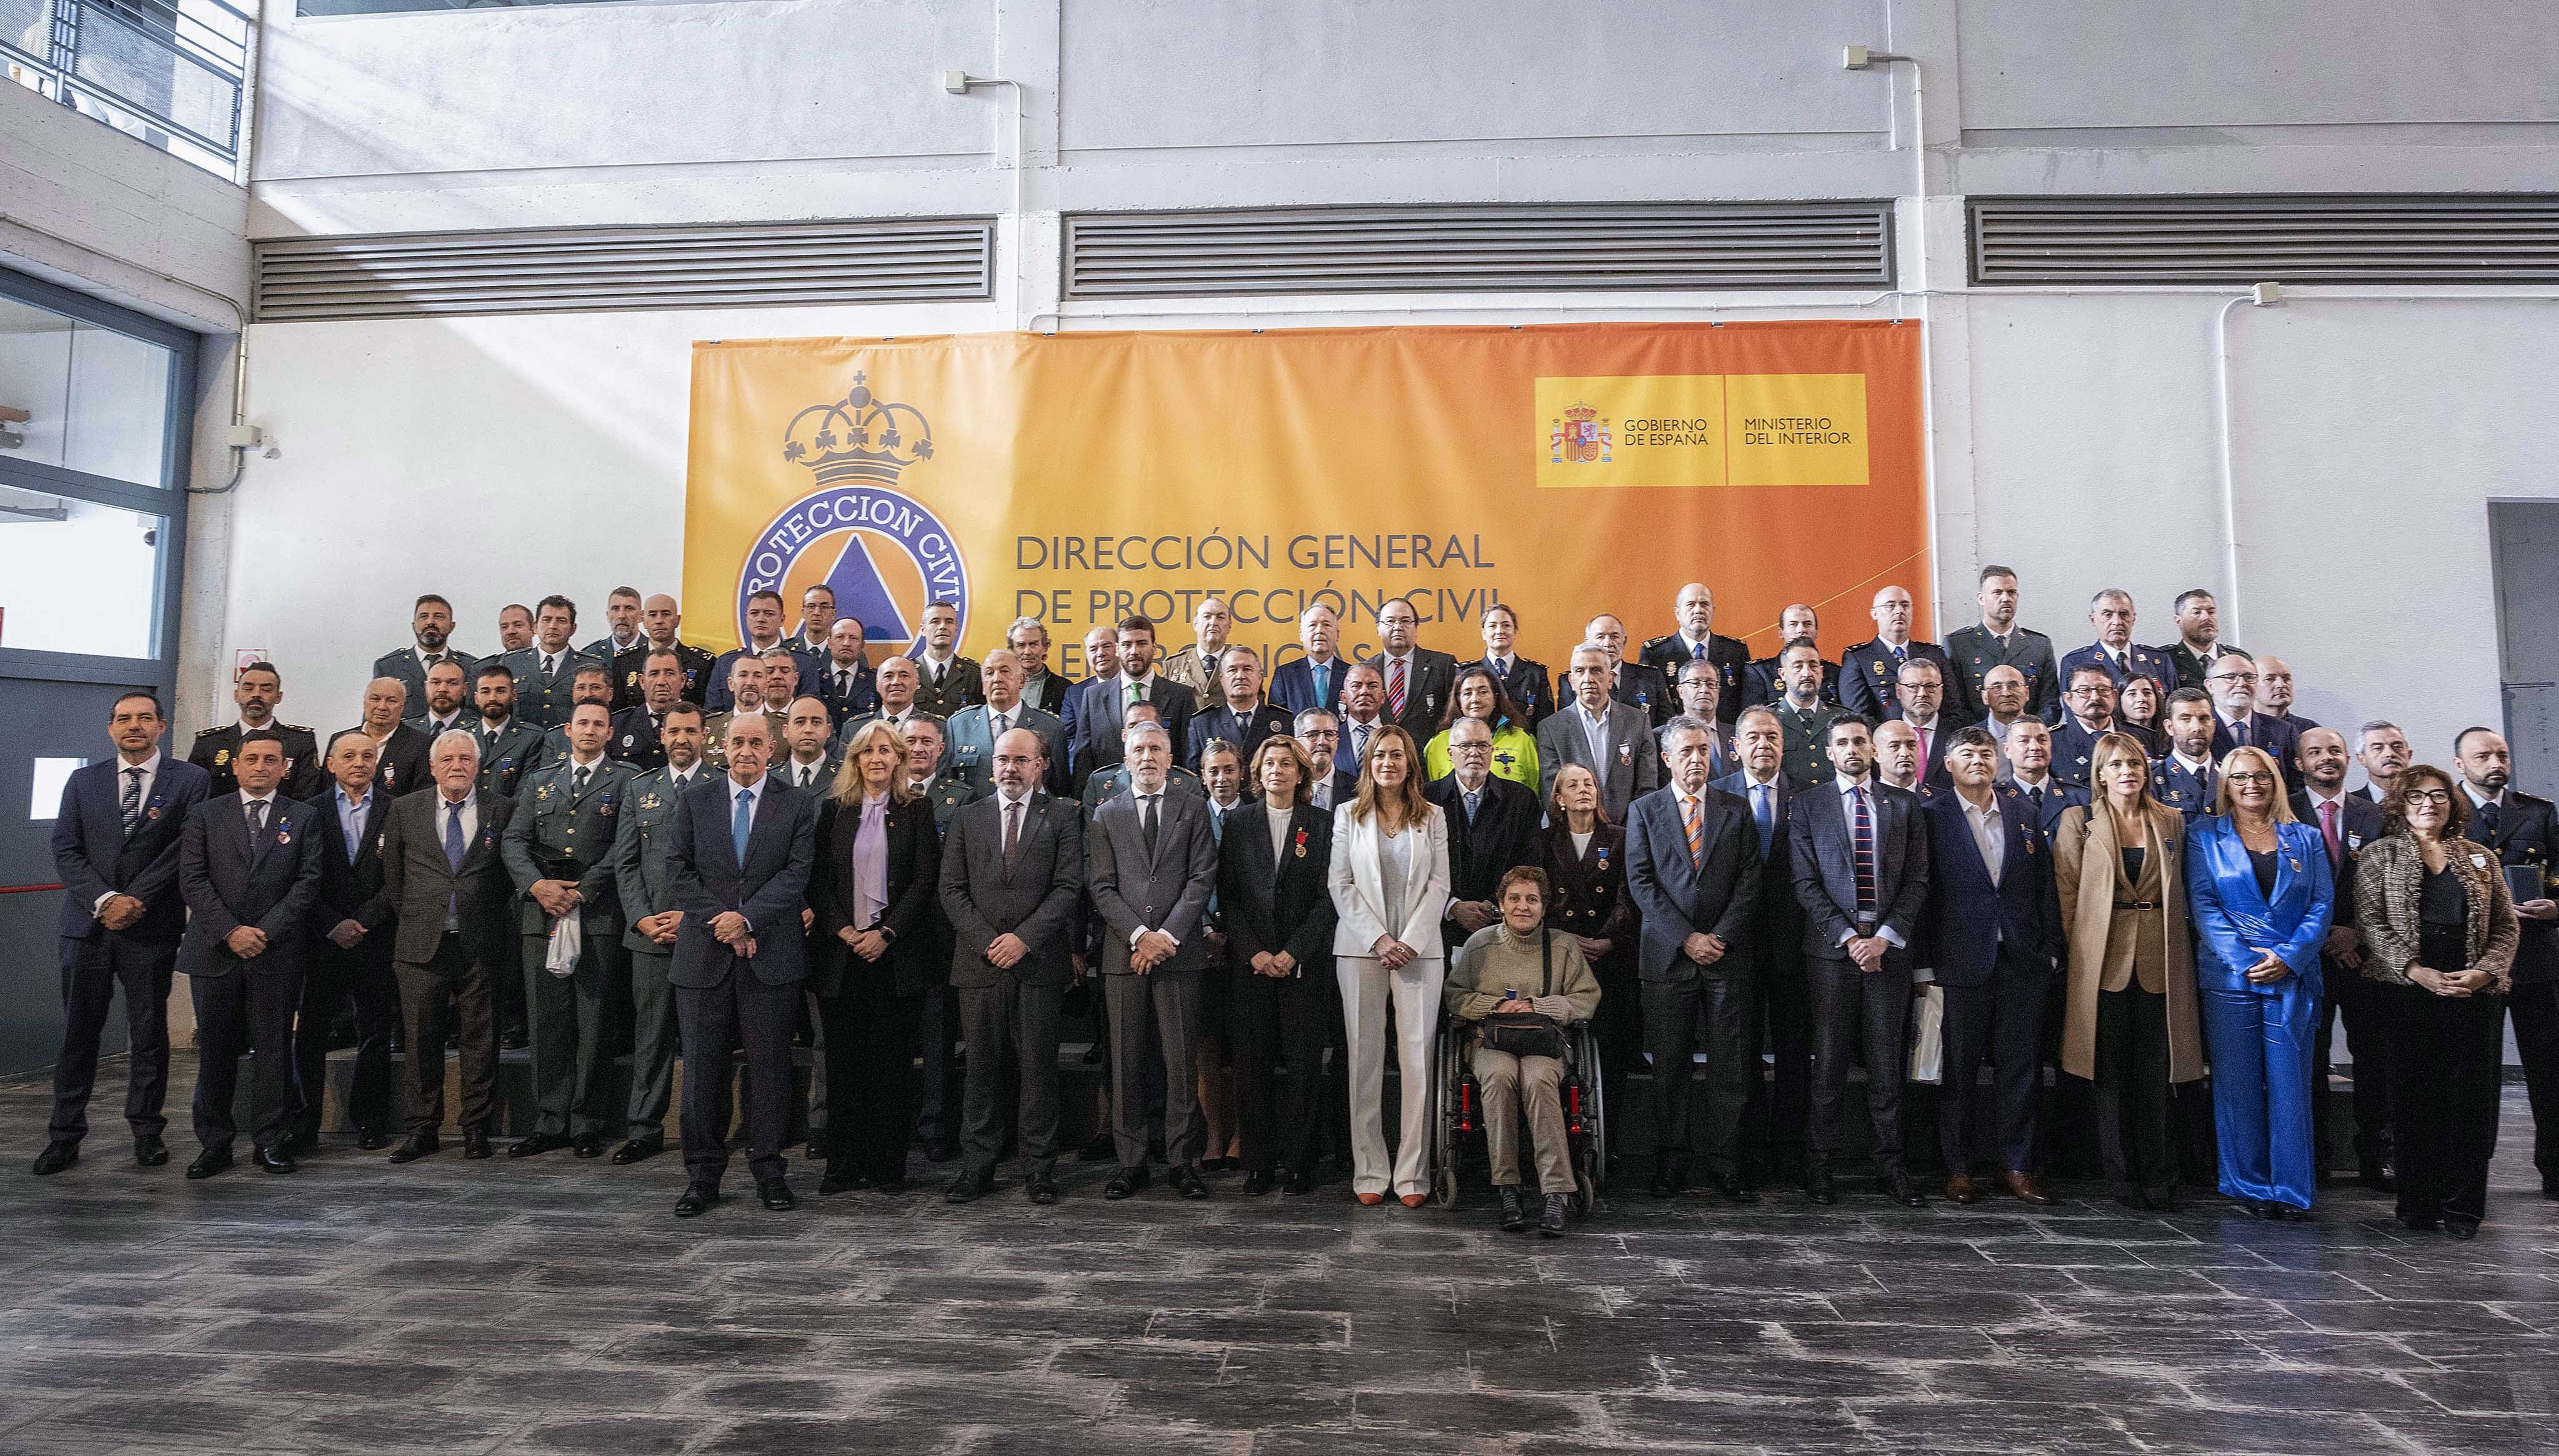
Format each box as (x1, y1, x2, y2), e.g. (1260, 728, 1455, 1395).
(942, 730, 1085, 1202)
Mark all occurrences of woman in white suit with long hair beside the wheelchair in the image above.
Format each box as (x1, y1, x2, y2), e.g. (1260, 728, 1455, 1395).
(1331, 726, 1448, 1208)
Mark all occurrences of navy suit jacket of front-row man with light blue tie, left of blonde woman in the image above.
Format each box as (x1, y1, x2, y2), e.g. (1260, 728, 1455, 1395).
(665, 773, 817, 990)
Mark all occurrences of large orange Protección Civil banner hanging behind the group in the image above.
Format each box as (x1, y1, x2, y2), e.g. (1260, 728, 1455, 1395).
(683, 322, 1929, 673)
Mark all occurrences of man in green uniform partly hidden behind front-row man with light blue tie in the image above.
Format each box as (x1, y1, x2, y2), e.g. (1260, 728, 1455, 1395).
(614, 701, 709, 1164)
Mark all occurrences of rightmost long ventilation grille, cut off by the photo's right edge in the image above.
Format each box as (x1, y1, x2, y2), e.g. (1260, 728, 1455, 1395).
(1970, 192, 2559, 284)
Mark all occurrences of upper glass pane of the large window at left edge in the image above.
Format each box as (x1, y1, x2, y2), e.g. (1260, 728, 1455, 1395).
(0, 299, 177, 486)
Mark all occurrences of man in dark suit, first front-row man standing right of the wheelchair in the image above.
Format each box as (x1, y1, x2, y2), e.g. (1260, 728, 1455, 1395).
(1625, 716, 1763, 1202)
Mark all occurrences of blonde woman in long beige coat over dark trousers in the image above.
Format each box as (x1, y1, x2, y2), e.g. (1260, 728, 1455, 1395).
(2052, 732, 2204, 1211)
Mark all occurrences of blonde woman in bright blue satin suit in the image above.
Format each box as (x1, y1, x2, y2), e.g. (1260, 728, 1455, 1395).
(2185, 747, 2337, 1218)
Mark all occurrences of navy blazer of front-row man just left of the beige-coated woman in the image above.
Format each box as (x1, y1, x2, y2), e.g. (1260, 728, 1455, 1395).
(1919, 783, 2062, 988)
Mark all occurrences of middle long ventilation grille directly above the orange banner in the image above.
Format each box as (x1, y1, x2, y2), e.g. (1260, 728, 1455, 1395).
(1067, 202, 1894, 299)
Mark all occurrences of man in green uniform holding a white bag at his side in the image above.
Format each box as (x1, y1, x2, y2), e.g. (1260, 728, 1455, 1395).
(499, 704, 632, 1157)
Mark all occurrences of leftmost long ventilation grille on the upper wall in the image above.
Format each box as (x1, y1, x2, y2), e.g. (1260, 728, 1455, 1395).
(256, 217, 995, 322)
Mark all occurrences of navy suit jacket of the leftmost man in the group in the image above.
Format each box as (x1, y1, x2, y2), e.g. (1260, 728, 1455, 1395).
(54, 747, 212, 947)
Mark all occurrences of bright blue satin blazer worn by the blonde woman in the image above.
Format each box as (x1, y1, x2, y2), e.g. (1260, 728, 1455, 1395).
(2185, 814, 2337, 996)
